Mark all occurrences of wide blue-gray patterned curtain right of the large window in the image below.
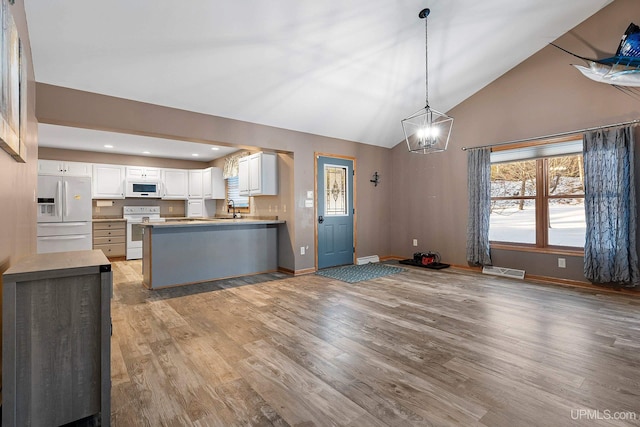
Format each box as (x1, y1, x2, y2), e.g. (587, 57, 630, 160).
(583, 127, 640, 287)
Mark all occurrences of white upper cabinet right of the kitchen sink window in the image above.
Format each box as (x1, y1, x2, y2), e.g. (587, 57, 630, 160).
(238, 152, 278, 196)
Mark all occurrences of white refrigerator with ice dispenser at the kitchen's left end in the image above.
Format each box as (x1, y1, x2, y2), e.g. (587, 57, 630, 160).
(37, 175, 93, 253)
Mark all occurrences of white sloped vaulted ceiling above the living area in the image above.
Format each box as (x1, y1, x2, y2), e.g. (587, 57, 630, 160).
(25, 0, 611, 156)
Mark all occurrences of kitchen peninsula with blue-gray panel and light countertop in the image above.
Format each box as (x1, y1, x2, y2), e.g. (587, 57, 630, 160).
(142, 219, 285, 289)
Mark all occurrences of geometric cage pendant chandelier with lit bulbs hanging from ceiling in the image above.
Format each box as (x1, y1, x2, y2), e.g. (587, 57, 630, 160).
(402, 9, 453, 154)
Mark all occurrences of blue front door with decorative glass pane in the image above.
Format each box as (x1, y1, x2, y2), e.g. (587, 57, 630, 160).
(316, 156, 355, 269)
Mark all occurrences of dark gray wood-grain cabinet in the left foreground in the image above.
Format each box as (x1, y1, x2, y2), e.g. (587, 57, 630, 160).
(2, 250, 113, 426)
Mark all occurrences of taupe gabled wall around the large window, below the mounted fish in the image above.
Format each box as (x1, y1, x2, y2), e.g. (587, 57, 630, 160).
(391, 0, 640, 281)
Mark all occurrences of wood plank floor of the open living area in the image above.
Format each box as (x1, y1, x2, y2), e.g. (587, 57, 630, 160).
(111, 261, 640, 427)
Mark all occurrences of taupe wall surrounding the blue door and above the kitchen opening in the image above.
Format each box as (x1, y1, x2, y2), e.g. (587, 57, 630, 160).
(36, 83, 392, 272)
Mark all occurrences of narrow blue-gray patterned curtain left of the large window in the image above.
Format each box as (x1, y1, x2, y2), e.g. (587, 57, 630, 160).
(467, 148, 491, 265)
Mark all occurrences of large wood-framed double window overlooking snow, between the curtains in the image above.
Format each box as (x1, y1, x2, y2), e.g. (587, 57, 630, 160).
(489, 139, 586, 249)
